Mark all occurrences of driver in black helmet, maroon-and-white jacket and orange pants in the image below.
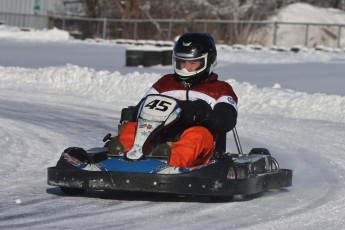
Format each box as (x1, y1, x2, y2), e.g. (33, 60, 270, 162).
(113, 33, 237, 167)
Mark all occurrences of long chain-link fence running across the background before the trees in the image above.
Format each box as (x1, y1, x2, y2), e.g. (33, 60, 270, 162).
(0, 13, 345, 48)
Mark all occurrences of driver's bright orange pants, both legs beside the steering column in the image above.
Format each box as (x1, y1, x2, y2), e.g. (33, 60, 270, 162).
(118, 122, 214, 167)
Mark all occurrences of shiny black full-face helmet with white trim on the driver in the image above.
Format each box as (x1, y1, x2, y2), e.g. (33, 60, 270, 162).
(172, 33, 217, 85)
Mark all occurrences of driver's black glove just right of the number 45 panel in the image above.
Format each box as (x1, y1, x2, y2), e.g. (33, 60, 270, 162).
(179, 99, 212, 124)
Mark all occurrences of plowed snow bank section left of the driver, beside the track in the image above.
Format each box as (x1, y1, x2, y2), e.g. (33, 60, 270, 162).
(0, 64, 161, 103)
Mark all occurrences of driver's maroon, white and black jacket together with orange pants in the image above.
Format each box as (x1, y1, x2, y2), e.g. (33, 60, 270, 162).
(118, 73, 238, 167)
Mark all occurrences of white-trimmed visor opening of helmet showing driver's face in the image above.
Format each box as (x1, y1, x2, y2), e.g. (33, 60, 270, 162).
(172, 53, 207, 79)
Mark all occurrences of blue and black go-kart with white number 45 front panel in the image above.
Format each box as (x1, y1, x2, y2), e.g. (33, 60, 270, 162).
(48, 95, 292, 198)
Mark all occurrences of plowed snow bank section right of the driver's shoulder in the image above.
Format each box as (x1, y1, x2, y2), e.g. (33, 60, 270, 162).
(228, 80, 345, 123)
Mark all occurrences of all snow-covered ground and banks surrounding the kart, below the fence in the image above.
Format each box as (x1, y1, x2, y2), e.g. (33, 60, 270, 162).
(0, 5, 345, 230)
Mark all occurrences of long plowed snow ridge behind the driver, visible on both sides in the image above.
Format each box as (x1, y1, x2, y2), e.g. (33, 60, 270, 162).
(0, 65, 345, 123)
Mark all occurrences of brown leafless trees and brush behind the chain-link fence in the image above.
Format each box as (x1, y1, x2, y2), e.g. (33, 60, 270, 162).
(76, 0, 345, 41)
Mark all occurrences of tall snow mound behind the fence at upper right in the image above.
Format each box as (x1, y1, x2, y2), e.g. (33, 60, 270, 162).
(253, 3, 345, 47)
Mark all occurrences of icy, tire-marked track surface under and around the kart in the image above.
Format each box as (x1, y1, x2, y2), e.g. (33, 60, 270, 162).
(0, 91, 345, 229)
